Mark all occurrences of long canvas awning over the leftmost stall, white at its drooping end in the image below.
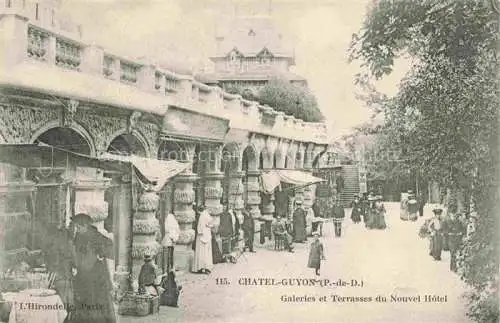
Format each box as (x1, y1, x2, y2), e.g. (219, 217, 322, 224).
(0, 144, 191, 190)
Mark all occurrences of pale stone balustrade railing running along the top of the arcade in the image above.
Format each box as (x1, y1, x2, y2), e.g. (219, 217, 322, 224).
(0, 8, 327, 144)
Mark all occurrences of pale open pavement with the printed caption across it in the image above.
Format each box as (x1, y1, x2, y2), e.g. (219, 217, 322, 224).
(118, 203, 469, 323)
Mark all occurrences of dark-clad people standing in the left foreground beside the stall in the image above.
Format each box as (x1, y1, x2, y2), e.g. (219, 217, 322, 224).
(36, 213, 116, 323)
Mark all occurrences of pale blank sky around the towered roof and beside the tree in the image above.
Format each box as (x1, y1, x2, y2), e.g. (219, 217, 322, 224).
(61, 0, 405, 139)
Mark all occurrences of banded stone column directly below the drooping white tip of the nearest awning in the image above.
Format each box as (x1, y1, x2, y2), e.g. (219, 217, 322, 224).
(132, 190, 160, 290)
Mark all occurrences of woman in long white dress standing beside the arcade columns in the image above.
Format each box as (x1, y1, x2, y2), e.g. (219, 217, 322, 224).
(193, 206, 213, 274)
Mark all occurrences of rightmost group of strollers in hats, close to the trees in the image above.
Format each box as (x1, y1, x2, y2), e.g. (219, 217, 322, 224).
(419, 207, 475, 272)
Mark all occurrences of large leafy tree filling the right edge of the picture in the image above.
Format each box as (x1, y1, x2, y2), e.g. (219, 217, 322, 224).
(350, 0, 500, 322)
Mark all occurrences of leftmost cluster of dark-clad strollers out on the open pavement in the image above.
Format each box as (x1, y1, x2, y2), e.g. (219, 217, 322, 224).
(351, 193, 387, 230)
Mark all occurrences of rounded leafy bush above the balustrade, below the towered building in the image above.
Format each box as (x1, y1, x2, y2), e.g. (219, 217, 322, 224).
(257, 79, 324, 122)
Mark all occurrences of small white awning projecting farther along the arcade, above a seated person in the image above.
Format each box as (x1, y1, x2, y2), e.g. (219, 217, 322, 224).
(261, 169, 325, 194)
